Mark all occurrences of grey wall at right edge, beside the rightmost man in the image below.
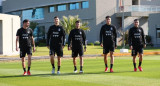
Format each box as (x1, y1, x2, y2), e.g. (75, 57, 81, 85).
(148, 13, 160, 47)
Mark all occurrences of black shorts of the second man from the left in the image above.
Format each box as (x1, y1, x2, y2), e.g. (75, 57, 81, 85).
(49, 45, 63, 57)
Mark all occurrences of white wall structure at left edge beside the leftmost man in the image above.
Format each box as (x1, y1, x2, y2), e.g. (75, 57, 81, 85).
(0, 14, 20, 55)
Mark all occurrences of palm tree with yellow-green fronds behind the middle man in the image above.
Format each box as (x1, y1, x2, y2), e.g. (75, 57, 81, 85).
(60, 15, 90, 34)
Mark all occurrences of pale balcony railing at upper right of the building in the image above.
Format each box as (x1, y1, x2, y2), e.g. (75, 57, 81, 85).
(117, 5, 160, 12)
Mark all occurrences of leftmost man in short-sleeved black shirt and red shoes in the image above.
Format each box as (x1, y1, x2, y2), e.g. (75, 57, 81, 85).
(16, 19, 36, 75)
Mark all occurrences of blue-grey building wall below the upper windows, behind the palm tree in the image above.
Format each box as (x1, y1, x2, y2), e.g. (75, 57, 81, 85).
(30, 0, 96, 42)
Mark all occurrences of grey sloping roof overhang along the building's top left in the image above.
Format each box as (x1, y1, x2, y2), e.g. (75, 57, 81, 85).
(2, 0, 87, 13)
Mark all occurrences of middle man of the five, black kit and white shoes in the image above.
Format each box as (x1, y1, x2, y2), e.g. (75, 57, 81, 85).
(68, 21, 86, 73)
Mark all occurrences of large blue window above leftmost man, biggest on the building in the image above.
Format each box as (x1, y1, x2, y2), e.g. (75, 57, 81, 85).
(22, 8, 44, 20)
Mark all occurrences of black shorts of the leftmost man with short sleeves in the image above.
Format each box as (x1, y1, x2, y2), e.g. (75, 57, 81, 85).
(20, 47, 32, 58)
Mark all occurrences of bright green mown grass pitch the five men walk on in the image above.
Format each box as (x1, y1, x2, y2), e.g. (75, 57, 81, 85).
(0, 55, 160, 86)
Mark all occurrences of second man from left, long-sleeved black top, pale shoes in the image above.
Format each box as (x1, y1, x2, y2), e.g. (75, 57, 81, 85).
(47, 16, 65, 74)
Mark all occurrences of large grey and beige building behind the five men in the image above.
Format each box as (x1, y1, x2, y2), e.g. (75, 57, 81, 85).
(2, 0, 160, 46)
